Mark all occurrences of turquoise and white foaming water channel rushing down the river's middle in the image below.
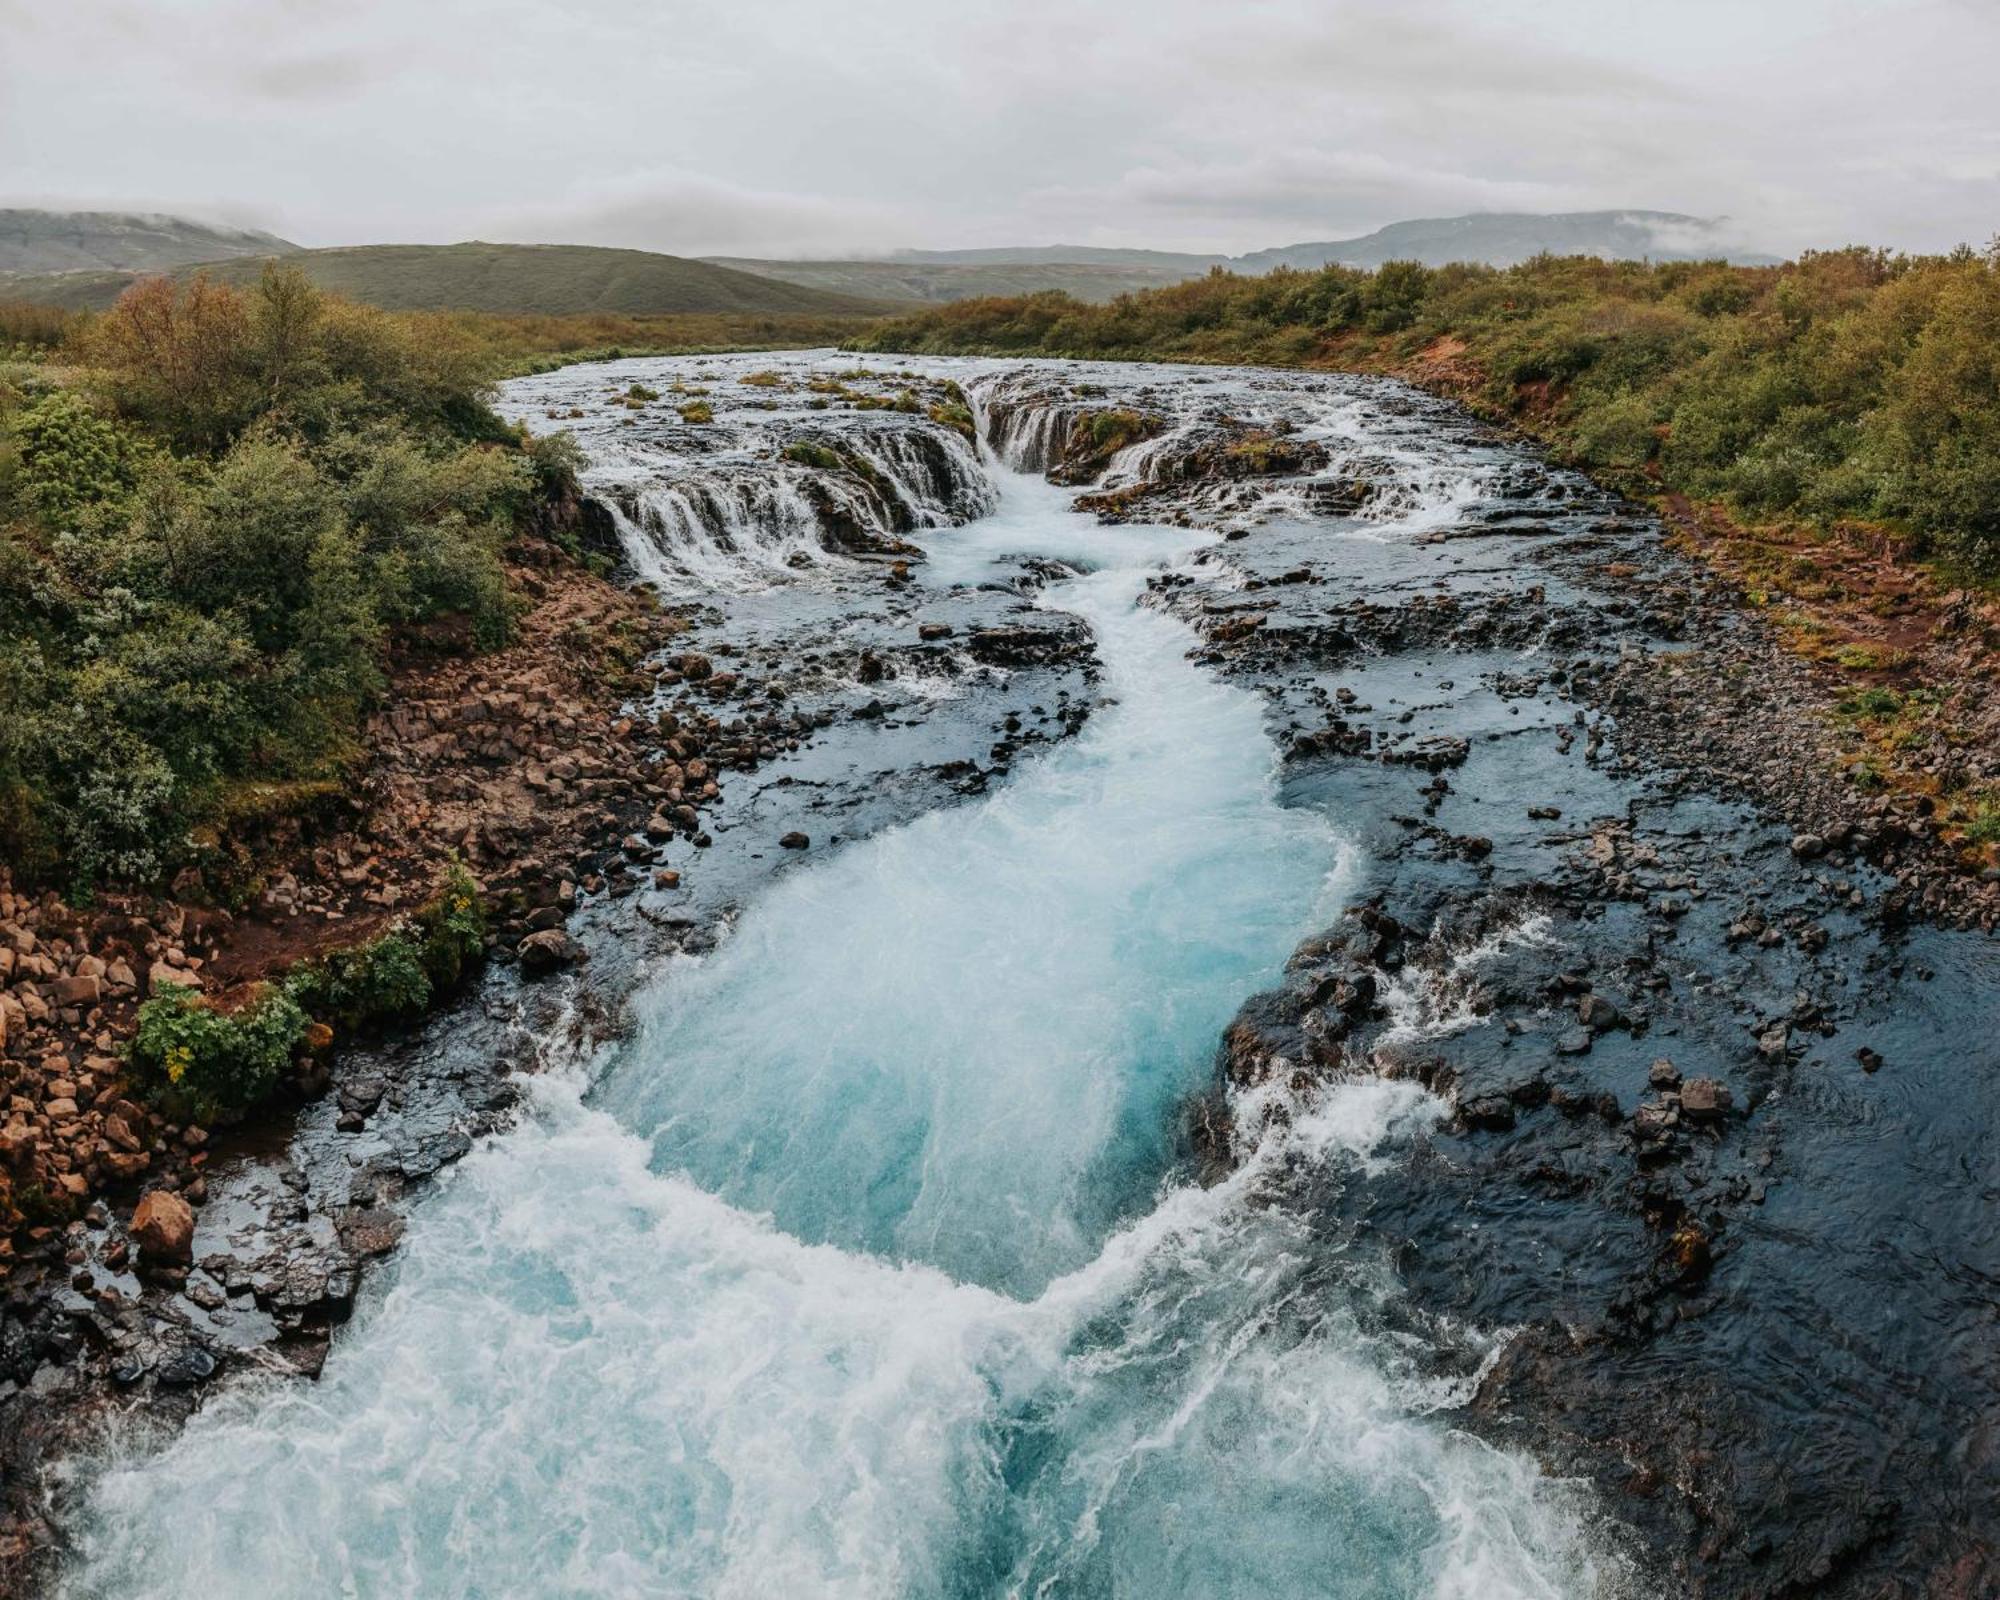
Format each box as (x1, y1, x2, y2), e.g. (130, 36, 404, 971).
(68, 364, 1598, 1600)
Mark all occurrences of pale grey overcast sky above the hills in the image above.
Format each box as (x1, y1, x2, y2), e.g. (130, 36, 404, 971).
(0, 0, 2000, 256)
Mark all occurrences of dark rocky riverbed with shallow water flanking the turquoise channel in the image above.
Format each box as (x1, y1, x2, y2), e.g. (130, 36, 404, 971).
(0, 358, 2000, 1600)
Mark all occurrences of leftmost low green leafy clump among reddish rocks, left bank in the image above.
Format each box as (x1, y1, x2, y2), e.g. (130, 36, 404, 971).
(130, 986, 308, 1122)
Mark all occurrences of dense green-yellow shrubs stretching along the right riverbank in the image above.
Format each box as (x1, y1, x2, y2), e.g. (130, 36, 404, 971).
(862, 250, 2000, 576)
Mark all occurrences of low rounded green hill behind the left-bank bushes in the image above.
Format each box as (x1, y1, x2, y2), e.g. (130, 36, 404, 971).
(0, 242, 882, 316)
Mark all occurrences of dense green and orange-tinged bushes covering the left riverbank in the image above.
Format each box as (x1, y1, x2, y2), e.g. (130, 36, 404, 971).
(0, 266, 572, 892)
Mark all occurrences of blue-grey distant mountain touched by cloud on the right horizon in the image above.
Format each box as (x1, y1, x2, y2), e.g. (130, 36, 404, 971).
(1230, 212, 1776, 272)
